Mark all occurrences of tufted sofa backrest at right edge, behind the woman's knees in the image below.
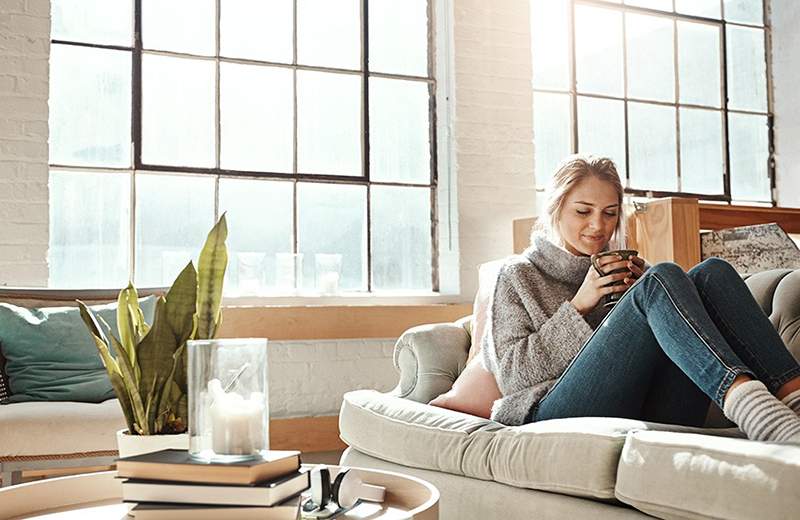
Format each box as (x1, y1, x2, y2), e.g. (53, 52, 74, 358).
(745, 269, 800, 361)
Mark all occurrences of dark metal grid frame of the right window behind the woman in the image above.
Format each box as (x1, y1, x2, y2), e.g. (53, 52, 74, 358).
(531, 0, 776, 206)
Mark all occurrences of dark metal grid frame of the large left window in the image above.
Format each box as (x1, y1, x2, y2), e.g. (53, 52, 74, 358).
(49, 0, 440, 292)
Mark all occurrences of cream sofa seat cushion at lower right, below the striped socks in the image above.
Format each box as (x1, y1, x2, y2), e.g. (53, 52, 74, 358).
(616, 431, 800, 519)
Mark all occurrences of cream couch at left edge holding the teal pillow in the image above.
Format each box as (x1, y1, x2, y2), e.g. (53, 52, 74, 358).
(0, 287, 159, 487)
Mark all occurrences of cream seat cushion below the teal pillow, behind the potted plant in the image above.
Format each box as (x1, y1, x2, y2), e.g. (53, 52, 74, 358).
(0, 399, 125, 460)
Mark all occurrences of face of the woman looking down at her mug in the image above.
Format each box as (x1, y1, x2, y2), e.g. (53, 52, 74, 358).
(558, 176, 620, 256)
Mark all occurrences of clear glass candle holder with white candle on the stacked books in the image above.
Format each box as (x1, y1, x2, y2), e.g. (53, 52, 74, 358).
(187, 338, 269, 462)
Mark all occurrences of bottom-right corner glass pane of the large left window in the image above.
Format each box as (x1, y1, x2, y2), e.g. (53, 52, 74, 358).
(370, 186, 431, 291)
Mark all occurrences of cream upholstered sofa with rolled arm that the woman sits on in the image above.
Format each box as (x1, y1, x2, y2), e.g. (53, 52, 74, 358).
(339, 269, 800, 520)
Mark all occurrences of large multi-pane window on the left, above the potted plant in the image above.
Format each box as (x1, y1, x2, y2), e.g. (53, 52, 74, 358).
(49, 0, 438, 294)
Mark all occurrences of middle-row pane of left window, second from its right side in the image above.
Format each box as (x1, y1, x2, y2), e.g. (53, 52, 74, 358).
(297, 70, 362, 176)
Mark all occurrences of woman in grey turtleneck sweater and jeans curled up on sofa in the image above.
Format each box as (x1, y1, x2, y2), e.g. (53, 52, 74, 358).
(483, 156, 800, 443)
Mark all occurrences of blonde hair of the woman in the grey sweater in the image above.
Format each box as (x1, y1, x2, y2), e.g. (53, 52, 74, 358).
(531, 154, 625, 248)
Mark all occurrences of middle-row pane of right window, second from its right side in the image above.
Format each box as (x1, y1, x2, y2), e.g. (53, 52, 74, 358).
(678, 21, 721, 107)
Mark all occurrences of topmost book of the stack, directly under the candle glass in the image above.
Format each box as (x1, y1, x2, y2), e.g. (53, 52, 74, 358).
(117, 450, 300, 484)
